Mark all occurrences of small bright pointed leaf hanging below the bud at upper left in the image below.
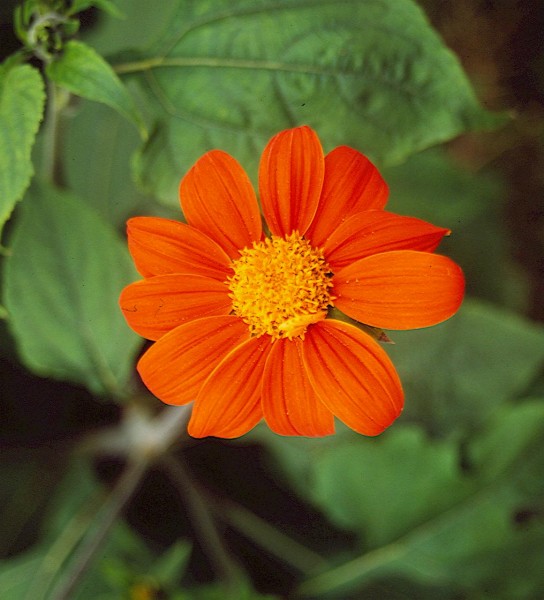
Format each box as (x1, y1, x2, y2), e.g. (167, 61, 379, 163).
(46, 40, 147, 138)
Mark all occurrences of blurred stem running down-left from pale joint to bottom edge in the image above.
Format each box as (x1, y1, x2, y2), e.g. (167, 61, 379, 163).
(50, 455, 149, 600)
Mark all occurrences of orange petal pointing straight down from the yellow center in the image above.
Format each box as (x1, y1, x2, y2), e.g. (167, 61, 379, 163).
(262, 339, 334, 437)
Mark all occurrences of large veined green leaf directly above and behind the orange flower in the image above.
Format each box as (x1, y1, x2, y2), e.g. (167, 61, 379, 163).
(116, 0, 497, 203)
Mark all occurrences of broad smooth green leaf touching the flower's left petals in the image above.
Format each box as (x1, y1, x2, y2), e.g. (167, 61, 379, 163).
(4, 187, 140, 395)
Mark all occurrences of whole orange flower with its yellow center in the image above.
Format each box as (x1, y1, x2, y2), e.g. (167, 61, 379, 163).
(120, 126, 464, 438)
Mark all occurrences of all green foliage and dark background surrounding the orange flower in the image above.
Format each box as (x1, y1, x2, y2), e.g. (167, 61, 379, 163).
(0, 0, 544, 600)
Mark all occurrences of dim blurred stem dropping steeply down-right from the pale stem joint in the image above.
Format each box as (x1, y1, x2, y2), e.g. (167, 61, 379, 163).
(161, 456, 241, 597)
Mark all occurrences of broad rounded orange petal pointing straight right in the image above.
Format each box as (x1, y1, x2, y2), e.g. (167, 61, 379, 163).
(332, 250, 465, 329)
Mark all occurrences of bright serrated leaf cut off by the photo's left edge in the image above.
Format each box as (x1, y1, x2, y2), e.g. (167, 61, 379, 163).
(0, 61, 45, 232)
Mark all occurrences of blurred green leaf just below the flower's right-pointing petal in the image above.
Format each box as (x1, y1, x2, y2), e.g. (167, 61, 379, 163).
(387, 300, 544, 435)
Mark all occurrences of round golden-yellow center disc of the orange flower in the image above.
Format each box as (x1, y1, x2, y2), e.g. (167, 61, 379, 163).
(227, 231, 333, 339)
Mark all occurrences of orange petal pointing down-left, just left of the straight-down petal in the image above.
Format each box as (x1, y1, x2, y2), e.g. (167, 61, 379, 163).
(188, 336, 272, 438)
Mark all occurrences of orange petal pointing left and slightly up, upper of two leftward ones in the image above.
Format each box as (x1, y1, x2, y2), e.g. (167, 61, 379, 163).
(127, 217, 231, 281)
